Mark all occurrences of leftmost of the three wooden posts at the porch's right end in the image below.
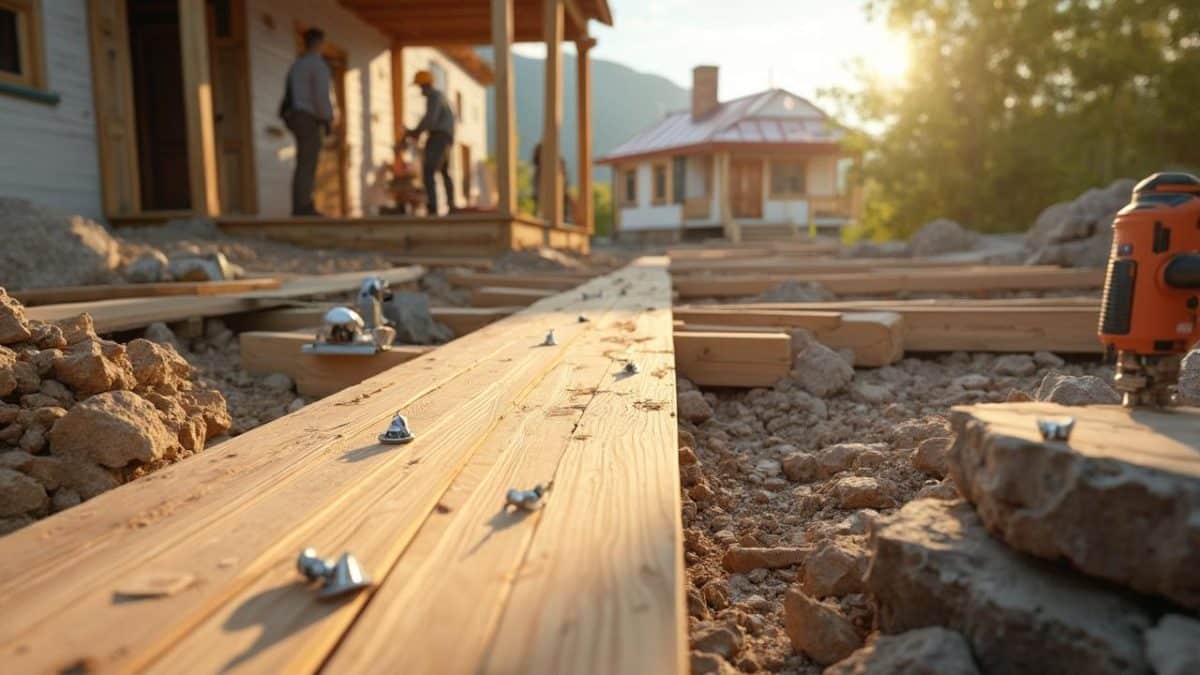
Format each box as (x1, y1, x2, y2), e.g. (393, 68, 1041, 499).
(491, 0, 517, 217)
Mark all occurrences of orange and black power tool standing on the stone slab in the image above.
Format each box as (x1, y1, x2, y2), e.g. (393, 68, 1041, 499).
(1100, 173, 1200, 407)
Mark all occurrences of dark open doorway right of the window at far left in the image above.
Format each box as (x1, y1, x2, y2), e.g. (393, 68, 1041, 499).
(128, 0, 192, 211)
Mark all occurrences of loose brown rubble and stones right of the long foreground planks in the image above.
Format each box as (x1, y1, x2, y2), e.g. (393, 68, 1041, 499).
(678, 331, 1180, 674)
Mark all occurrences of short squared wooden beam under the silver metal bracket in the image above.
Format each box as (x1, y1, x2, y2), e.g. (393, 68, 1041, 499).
(238, 330, 436, 396)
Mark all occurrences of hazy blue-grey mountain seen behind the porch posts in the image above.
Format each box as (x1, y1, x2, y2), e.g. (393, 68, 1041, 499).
(487, 54, 691, 181)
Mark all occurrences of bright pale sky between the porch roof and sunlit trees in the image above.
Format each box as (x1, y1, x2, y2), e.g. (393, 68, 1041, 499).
(516, 0, 907, 100)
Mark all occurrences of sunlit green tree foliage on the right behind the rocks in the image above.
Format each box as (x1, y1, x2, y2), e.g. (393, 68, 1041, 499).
(826, 0, 1200, 238)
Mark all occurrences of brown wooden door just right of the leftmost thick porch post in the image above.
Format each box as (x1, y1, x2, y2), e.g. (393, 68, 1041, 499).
(205, 0, 258, 214)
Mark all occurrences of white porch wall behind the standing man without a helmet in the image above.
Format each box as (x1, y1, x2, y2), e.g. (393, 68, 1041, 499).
(246, 0, 392, 216)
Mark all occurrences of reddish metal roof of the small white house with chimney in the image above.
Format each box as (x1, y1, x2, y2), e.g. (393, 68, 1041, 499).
(596, 89, 845, 163)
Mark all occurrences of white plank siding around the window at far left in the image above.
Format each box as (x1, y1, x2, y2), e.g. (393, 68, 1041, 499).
(0, 0, 103, 220)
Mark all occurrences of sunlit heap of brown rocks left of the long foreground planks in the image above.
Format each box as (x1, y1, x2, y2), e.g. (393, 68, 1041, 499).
(0, 288, 230, 533)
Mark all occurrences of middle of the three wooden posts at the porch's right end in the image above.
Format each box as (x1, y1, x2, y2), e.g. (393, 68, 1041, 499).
(538, 0, 563, 225)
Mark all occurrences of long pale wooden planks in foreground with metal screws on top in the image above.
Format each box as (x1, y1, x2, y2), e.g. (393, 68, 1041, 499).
(0, 258, 688, 674)
